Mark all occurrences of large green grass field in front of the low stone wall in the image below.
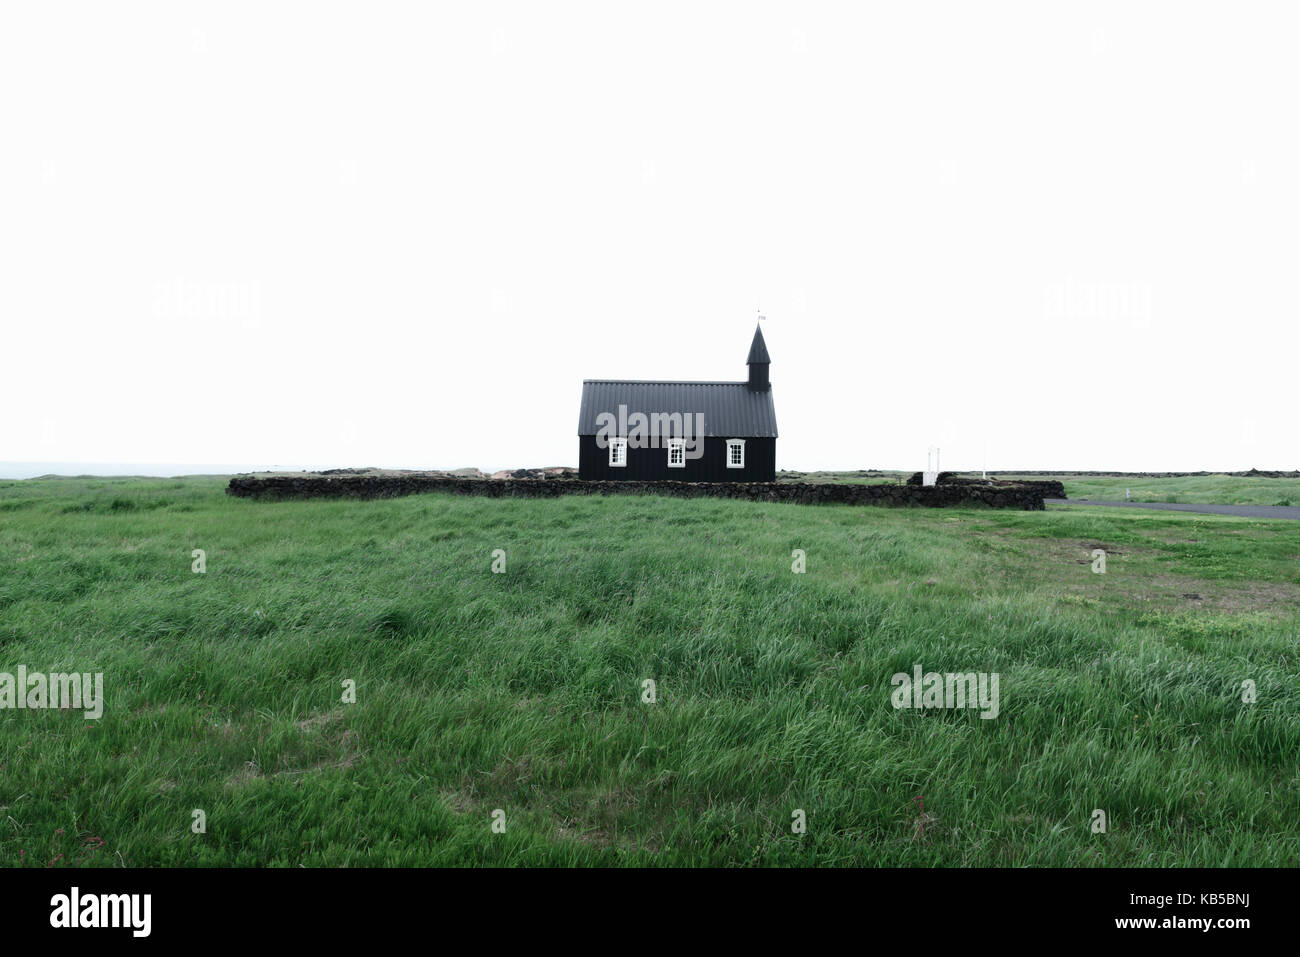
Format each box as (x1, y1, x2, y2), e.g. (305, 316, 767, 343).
(0, 479, 1300, 867)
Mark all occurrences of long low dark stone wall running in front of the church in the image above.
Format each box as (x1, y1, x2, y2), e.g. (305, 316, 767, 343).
(226, 475, 1047, 511)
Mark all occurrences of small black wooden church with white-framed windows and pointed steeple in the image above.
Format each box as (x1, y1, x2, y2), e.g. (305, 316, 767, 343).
(577, 328, 776, 482)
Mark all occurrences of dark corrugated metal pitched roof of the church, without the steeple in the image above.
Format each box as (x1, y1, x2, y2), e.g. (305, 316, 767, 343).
(577, 378, 776, 438)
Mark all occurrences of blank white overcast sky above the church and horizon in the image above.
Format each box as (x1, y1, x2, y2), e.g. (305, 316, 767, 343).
(0, 0, 1300, 471)
